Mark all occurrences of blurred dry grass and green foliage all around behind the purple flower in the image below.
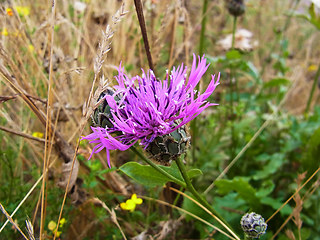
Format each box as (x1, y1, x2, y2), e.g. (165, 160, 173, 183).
(0, 0, 320, 240)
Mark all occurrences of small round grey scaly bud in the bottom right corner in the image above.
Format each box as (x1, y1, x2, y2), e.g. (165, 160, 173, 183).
(240, 212, 267, 238)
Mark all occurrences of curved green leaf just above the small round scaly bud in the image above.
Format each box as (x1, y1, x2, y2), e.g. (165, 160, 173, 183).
(215, 177, 260, 209)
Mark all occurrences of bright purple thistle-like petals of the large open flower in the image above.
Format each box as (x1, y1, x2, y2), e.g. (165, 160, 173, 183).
(82, 55, 220, 167)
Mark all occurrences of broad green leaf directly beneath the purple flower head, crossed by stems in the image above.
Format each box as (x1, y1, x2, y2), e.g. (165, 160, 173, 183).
(119, 162, 198, 187)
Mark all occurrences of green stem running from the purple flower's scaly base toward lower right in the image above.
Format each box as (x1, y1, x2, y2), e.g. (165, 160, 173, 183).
(176, 158, 232, 232)
